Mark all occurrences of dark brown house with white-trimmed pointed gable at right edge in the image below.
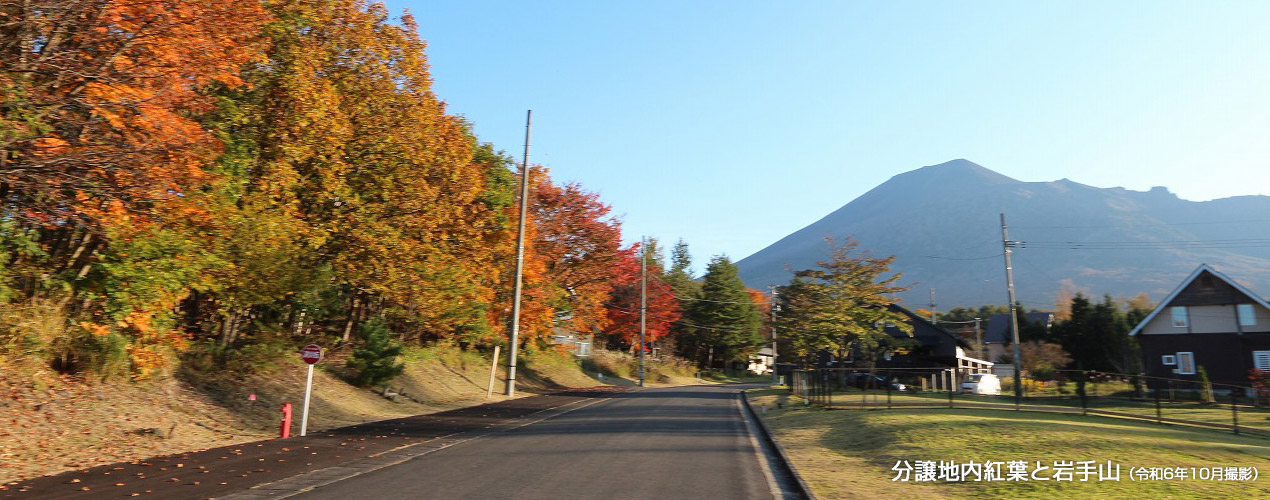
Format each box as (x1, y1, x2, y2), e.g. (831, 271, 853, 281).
(1129, 264, 1270, 386)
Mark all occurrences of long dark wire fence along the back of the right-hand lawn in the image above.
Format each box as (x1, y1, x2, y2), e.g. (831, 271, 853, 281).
(790, 368, 1270, 438)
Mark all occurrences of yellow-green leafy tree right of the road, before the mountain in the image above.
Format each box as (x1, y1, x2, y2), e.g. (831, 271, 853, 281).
(777, 239, 911, 359)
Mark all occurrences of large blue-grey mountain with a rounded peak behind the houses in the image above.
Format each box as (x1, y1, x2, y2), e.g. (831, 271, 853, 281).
(737, 160, 1270, 310)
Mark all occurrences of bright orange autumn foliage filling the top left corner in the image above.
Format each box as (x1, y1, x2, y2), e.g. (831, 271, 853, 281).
(0, 0, 269, 227)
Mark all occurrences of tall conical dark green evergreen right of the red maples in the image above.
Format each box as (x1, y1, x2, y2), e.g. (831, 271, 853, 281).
(679, 255, 763, 367)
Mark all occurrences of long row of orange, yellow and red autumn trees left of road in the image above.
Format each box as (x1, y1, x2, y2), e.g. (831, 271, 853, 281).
(0, 0, 732, 378)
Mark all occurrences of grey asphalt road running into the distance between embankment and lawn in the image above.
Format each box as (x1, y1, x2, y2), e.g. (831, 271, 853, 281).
(292, 386, 773, 500)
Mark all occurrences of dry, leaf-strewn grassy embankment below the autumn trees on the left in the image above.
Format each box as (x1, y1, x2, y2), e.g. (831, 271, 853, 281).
(0, 345, 696, 482)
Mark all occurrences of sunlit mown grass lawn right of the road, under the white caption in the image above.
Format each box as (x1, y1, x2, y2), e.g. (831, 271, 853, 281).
(749, 390, 1270, 500)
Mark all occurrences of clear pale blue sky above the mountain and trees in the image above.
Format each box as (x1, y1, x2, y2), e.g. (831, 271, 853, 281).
(387, 0, 1270, 272)
